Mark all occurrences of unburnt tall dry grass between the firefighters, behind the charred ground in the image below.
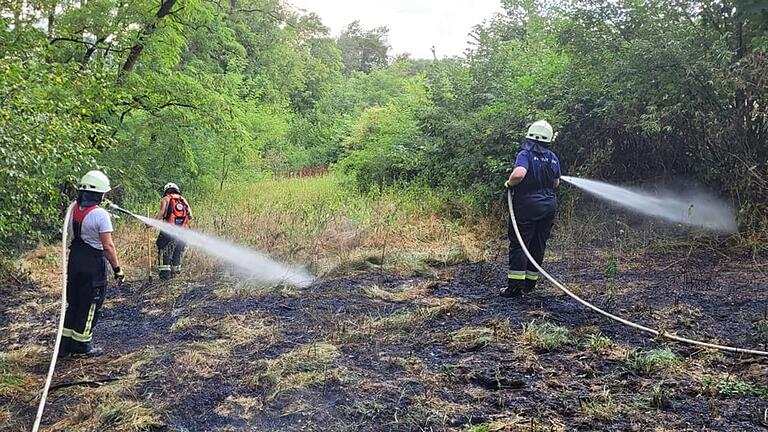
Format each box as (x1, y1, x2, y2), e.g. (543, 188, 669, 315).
(43, 174, 498, 284)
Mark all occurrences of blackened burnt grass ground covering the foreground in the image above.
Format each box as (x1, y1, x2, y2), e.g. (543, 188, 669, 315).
(0, 250, 768, 431)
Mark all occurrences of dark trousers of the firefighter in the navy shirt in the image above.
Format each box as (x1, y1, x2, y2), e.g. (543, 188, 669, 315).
(507, 194, 557, 291)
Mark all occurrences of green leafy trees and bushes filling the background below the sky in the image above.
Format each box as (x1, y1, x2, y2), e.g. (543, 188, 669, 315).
(0, 0, 768, 250)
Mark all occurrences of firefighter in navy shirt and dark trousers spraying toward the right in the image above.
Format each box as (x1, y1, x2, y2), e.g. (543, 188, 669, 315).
(501, 120, 560, 297)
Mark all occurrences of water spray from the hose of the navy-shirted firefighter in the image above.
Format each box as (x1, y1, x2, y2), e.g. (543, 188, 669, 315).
(562, 176, 737, 233)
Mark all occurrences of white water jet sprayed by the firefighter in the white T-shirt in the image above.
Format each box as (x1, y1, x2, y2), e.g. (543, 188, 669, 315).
(133, 215, 313, 287)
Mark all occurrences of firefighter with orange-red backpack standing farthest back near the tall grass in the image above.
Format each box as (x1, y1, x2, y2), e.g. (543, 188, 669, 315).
(156, 183, 192, 280)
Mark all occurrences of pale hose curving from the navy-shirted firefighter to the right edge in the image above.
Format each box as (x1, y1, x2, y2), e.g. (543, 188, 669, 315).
(507, 190, 768, 356)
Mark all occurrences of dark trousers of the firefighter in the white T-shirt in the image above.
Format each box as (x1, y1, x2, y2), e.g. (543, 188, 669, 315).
(62, 239, 108, 353)
